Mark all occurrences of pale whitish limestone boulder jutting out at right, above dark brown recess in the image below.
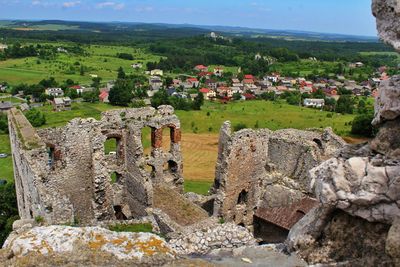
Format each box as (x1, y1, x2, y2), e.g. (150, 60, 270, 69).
(310, 157, 400, 224)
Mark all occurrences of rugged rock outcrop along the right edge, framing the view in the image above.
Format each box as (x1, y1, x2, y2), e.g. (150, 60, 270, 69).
(287, 0, 400, 266)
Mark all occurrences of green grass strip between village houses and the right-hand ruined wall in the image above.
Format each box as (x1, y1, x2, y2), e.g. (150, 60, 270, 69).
(176, 100, 354, 136)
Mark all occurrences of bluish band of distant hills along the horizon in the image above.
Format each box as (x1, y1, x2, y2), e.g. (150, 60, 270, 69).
(0, 20, 379, 42)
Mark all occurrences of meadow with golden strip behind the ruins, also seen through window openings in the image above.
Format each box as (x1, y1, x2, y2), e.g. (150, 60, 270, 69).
(0, 100, 354, 193)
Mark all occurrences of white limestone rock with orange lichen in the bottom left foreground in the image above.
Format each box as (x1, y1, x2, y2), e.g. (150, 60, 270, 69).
(3, 226, 175, 263)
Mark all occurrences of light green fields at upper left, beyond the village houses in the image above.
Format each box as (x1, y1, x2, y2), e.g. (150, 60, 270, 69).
(0, 43, 160, 85)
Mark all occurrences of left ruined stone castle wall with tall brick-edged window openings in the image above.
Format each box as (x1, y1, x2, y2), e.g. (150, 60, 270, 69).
(9, 106, 183, 224)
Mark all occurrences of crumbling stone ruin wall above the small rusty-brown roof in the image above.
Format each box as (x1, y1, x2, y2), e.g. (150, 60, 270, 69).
(213, 122, 344, 226)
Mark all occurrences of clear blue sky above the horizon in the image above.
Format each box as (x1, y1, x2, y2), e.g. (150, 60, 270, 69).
(0, 0, 377, 36)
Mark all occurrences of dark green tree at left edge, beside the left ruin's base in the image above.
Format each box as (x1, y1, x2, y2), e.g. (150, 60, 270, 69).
(0, 183, 19, 247)
